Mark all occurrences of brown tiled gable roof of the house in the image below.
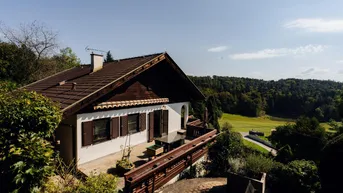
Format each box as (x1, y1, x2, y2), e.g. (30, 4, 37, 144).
(23, 53, 207, 117)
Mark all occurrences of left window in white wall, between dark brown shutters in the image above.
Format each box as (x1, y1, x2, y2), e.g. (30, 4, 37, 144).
(93, 119, 110, 143)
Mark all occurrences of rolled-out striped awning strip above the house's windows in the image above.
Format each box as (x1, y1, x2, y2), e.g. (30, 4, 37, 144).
(94, 98, 169, 110)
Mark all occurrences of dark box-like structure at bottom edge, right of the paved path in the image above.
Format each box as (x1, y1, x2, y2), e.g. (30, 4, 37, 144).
(227, 172, 267, 193)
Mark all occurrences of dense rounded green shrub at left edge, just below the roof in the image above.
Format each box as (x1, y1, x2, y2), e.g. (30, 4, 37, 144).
(0, 90, 62, 138)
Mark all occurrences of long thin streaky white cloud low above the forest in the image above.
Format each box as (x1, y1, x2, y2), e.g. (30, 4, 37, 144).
(229, 44, 327, 60)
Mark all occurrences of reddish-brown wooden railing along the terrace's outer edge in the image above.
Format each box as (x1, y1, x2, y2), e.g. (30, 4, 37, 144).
(124, 129, 217, 193)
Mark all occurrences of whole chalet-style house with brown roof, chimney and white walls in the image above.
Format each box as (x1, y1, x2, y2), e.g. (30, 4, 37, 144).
(25, 53, 204, 165)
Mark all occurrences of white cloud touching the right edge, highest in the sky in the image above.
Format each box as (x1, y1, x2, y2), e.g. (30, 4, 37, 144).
(284, 18, 343, 32)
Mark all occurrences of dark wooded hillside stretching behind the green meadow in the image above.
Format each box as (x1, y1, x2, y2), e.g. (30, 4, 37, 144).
(189, 76, 343, 121)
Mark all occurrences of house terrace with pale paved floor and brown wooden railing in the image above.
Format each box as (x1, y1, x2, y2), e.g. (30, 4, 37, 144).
(78, 120, 216, 192)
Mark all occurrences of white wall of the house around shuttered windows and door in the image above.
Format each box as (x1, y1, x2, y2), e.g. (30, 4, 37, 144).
(76, 102, 189, 165)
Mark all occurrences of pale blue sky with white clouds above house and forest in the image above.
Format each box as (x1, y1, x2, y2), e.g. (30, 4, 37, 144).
(0, 0, 343, 81)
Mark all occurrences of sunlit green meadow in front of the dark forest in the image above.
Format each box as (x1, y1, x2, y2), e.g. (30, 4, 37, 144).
(219, 113, 330, 136)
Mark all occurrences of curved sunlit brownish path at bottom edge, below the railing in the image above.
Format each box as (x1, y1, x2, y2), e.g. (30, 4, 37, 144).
(156, 178, 227, 193)
